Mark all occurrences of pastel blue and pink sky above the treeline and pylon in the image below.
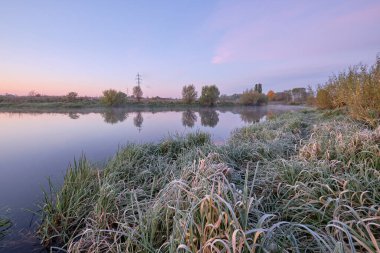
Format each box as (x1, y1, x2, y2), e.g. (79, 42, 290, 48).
(0, 0, 380, 97)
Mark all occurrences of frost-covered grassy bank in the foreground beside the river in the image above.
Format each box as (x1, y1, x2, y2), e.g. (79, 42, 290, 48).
(39, 111, 380, 252)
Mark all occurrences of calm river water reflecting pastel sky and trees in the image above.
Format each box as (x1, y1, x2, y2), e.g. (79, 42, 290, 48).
(0, 105, 300, 252)
